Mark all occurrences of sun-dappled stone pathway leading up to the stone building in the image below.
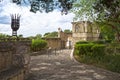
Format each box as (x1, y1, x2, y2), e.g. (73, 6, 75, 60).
(28, 50, 120, 80)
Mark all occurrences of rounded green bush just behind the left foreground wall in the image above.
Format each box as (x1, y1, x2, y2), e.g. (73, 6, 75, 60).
(31, 39, 47, 51)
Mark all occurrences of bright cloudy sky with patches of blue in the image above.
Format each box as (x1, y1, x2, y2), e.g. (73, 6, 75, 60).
(0, 0, 74, 37)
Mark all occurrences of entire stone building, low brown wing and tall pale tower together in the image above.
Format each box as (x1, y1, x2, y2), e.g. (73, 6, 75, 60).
(45, 21, 100, 49)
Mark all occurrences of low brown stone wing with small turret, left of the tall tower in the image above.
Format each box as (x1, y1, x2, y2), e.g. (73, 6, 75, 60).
(43, 28, 72, 49)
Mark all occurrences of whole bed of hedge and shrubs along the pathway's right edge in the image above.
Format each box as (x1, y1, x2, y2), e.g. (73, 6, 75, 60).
(74, 42, 120, 73)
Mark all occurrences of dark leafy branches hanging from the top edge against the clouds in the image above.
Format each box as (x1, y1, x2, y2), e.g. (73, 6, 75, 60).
(5, 0, 76, 14)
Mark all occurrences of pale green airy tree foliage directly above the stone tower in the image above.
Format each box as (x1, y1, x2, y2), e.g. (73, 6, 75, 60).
(71, 0, 96, 21)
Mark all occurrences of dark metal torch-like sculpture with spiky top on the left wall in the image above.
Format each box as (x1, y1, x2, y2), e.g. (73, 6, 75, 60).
(11, 14, 20, 36)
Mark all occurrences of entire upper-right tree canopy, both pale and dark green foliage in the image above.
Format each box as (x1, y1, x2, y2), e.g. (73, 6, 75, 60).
(72, 0, 120, 41)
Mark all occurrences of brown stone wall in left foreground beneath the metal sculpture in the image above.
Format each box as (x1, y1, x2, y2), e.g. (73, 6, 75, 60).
(0, 38, 31, 80)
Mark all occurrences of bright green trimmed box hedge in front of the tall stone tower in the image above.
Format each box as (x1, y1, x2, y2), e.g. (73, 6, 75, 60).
(75, 43, 105, 57)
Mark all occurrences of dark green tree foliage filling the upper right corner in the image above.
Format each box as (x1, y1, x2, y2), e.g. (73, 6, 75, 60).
(93, 0, 120, 41)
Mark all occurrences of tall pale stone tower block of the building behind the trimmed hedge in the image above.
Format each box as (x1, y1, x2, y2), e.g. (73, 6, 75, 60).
(69, 21, 100, 46)
